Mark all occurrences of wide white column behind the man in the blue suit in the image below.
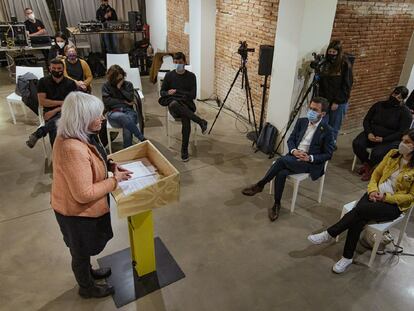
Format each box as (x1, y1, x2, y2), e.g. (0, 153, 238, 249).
(267, 0, 337, 151)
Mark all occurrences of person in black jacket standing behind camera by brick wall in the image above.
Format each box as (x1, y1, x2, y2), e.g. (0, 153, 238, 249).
(318, 40, 353, 148)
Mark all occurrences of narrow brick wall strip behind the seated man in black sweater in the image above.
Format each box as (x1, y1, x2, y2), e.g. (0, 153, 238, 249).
(167, 0, 190, 62)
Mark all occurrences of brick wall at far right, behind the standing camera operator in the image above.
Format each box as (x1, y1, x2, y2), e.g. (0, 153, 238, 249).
(332, 0, 414, 130)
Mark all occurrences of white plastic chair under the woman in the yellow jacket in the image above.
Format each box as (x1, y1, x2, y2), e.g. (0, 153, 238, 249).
(336, 201, 413, 267)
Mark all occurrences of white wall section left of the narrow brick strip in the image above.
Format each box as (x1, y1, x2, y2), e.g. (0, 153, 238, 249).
(145, 0, 167, 51)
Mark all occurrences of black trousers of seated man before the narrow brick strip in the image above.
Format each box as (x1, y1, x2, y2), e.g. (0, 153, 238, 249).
(168, 100, 203, 153)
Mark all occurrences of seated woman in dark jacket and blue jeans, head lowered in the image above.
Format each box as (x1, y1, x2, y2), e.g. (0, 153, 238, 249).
(102, 65, 146, 148)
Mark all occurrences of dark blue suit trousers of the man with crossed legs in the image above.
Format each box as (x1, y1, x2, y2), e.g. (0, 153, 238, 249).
(257, 155, 312, 204)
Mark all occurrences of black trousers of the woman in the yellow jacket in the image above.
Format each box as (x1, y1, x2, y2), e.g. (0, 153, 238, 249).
(327, 193, 401, 259)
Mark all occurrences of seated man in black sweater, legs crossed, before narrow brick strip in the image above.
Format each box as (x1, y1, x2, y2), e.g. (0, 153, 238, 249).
(160, 52, 208, 162)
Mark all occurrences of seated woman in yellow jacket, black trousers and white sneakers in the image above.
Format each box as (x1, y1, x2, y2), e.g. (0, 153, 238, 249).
(308, 130, 414, 273)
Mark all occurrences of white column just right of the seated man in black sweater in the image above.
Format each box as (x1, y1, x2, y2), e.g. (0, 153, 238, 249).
(189, 0, 216, 98)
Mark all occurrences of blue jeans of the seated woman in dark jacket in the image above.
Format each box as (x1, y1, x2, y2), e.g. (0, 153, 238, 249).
(107, 109, 144, 148)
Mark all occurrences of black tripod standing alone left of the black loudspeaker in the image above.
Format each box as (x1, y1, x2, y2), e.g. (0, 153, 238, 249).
(208, 56, 259, 140)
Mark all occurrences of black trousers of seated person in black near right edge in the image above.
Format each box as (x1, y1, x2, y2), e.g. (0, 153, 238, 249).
(352, 132, 400, 166)
